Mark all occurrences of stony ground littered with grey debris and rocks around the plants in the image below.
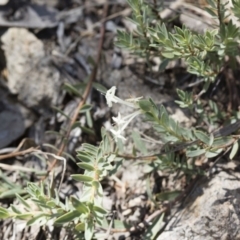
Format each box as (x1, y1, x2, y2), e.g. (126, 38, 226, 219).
(0, 0, 240, 240)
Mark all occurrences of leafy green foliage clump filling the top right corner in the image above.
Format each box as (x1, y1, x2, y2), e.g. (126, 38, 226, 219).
(116, 0, 240, 82)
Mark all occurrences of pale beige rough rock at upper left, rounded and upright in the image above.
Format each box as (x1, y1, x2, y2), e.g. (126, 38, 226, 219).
(1, 28, 61, 111)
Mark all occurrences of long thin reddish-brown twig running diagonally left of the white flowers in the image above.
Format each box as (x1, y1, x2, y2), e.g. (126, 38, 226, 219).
(42, 3, 108, 180)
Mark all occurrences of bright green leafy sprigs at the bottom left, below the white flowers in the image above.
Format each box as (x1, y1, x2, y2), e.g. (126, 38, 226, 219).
(0, 130, 120, 240)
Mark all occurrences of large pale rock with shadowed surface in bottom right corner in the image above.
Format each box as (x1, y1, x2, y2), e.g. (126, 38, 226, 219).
(157, 171, 240, 240)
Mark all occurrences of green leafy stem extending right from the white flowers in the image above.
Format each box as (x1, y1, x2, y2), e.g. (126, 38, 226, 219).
(139, 99, 238, 163)
